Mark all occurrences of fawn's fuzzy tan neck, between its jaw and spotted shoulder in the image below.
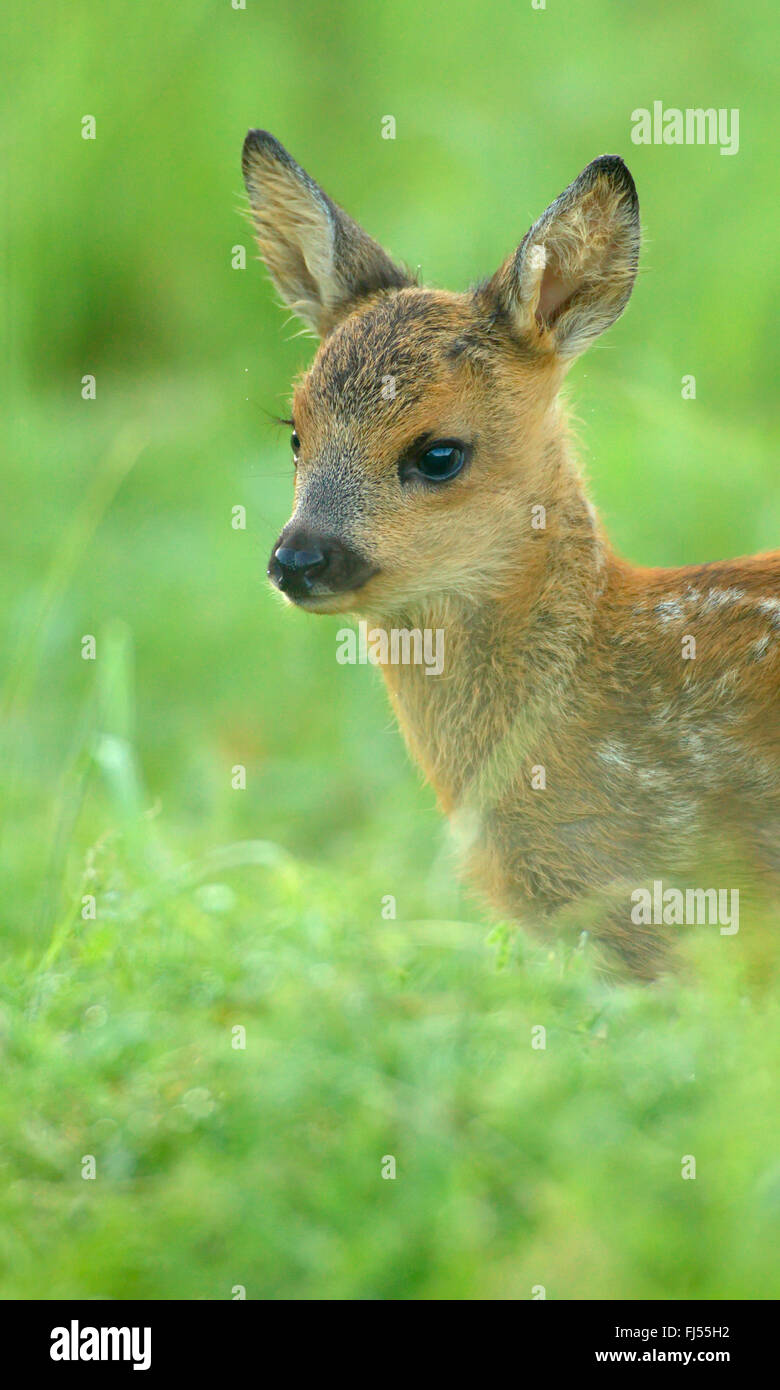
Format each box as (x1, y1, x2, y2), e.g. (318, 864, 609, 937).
(382, 428, 609, 812)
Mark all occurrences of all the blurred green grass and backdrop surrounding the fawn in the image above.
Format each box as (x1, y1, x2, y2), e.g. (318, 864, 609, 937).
(0, 0, 780, 1298)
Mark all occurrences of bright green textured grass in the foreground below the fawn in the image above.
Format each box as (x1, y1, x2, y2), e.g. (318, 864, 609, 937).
(0, 748, 780, 1300)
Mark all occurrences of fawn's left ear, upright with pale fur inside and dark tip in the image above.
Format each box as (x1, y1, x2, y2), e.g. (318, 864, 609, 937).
(242, 131, 414, 338)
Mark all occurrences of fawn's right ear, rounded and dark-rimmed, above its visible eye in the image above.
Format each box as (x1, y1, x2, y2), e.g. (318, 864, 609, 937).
(487, 154, 640, 357)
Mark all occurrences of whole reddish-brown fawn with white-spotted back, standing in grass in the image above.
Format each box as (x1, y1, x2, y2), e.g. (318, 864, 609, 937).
(243, 131, 780, 979)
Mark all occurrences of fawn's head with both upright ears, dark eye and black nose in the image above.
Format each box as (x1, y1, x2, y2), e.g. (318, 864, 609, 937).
(243, 131, 640, 613)
